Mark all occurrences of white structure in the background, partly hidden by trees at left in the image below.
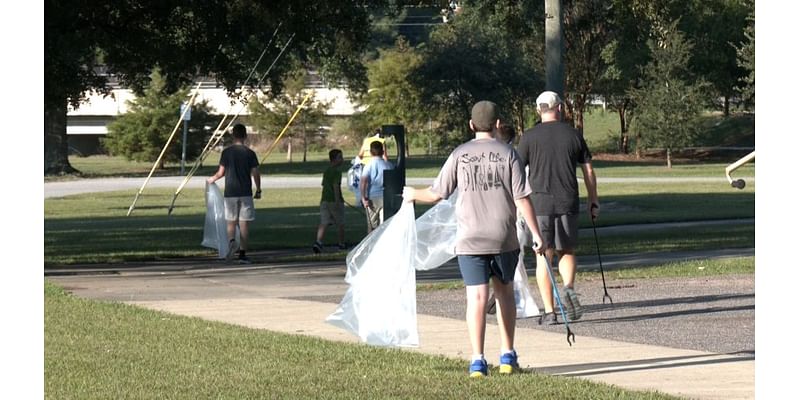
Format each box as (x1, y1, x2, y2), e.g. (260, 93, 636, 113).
(67, 74, 364, 155)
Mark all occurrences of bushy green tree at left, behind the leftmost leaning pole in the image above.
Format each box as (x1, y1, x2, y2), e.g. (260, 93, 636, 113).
(102, 72, 219, 168)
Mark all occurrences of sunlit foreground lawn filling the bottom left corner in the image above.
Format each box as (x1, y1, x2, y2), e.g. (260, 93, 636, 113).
(44, 282, 675, 399)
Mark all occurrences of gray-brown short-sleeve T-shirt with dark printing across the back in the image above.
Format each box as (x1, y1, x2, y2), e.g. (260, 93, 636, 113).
(431, 139, 531, 255)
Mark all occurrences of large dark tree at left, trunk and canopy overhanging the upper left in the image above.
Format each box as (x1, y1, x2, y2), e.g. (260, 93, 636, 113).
(44, 0, 376, 174)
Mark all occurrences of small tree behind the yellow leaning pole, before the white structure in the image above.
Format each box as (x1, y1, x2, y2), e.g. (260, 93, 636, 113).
(247, 63, 330, 162)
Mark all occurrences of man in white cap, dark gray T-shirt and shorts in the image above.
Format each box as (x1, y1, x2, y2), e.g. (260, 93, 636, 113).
(517, 91, 600, 325)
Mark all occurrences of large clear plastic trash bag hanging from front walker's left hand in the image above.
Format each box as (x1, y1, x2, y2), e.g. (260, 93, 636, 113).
(325, 203, 419, 347)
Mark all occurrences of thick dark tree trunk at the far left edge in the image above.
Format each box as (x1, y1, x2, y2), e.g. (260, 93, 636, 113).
(44, 100, 80, 175)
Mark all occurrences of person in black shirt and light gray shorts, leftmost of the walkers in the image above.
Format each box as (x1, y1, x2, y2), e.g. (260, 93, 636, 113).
(208, 124, 261, 264)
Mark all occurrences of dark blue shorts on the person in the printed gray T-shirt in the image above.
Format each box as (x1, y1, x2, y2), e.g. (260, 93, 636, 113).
(458, 250, 519, 286)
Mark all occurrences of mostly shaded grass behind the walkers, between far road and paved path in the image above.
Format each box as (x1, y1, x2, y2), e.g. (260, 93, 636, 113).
(44, 183, 755, 266)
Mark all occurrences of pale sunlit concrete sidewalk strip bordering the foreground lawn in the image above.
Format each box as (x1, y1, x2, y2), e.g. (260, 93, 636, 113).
(130, 298, 755, 400)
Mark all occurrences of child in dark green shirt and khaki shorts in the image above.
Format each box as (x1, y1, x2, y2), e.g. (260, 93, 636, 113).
(311, 149, 347, 254)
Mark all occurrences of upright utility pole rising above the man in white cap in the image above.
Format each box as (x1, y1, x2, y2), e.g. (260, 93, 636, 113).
(544, 0, 564, 99)
